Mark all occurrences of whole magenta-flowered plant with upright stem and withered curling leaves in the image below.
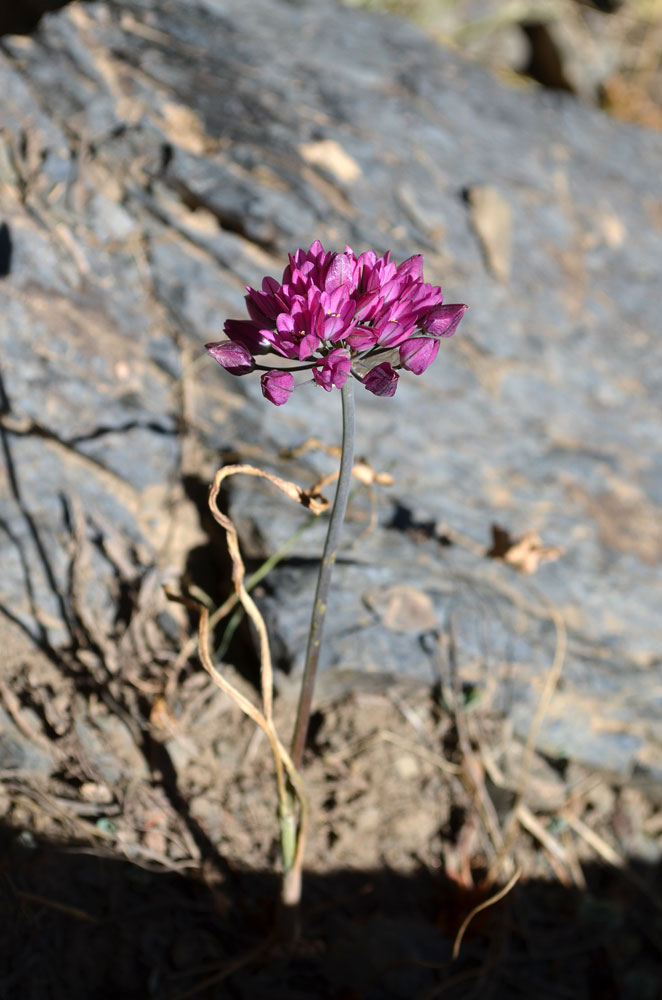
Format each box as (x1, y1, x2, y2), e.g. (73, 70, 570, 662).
(199, 240, 467, 937)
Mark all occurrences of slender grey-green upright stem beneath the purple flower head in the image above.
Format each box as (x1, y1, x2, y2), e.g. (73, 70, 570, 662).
(292, 378, 354, 771)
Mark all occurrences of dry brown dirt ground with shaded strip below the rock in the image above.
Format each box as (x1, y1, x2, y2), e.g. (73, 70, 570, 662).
(0, 624, 662, 1000)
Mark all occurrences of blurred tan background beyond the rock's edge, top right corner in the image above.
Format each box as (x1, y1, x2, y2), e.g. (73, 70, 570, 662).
(346, 0, 662, 128)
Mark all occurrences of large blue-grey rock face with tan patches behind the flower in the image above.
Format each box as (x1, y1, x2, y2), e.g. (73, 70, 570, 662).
(0, 0, 662, 777)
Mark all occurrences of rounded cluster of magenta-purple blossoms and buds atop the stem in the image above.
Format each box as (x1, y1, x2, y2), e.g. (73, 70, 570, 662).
(206, 240, 467, 406)
